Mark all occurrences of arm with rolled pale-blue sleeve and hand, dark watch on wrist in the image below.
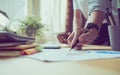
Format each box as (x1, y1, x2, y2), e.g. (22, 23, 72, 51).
(79, 0, 111, 44)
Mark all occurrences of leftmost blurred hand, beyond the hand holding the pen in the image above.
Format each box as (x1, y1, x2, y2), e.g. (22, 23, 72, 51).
(57, 32, 70, 44)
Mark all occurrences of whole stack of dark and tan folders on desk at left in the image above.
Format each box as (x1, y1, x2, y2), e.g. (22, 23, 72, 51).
(0, 31, 38, 56)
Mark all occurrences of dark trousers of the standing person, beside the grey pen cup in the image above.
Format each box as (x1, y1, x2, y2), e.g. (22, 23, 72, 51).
(91, 23, 110, 46)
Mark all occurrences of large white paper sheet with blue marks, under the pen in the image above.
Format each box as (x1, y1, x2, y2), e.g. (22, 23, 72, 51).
(26, 50, 120, 61)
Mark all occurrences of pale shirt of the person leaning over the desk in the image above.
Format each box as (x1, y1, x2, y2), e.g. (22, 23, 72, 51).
(73, 0, 119, 24)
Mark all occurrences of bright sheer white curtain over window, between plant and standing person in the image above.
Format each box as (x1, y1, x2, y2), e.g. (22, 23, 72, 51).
(40, 0, 67, 41)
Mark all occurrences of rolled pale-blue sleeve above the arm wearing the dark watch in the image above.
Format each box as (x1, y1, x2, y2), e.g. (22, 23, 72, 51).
(88, 0, 112, 15)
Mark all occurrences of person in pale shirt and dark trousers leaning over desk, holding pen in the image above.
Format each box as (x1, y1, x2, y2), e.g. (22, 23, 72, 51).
(57, 0, 118, 49)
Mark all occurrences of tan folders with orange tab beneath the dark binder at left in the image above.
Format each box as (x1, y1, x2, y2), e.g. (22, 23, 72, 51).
(0, 43, 40, 57)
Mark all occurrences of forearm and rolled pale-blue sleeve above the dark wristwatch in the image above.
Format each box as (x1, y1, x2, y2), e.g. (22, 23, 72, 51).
(85, 0, 112, 27)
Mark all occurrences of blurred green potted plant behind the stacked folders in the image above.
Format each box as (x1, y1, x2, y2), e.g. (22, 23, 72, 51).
(19, 16, 44, 37)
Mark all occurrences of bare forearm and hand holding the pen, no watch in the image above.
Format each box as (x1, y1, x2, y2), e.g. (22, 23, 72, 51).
(67, 9, 86, 49)
